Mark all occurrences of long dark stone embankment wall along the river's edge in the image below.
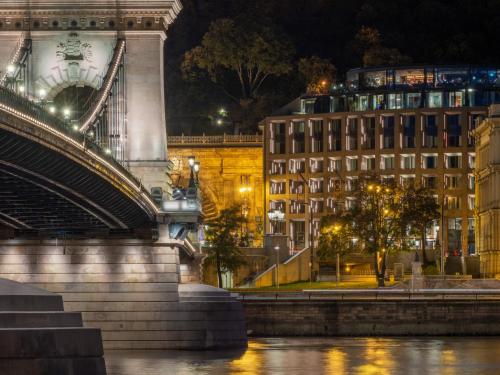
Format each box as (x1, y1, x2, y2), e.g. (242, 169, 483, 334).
(243, 299, 500, 336)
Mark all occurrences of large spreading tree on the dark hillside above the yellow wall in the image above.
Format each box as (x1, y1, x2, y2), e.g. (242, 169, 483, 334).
(182, 17, 294, 132)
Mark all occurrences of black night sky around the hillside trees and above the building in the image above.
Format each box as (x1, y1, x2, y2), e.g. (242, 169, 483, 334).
(166, 0, 500, 134)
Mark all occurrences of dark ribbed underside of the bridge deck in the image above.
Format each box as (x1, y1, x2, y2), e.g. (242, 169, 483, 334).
(0, 126, 153, 237)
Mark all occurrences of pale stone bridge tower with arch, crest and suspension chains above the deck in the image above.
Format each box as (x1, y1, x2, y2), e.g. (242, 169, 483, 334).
(0, 0, 181, 189)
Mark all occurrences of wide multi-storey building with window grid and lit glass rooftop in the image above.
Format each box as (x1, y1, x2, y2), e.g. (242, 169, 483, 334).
(265, 66, 500, 255)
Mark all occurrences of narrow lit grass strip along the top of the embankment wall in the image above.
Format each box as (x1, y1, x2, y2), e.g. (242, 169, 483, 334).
(231, 277, 394, 292)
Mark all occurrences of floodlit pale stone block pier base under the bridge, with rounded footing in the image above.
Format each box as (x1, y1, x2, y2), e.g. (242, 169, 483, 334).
(0, 240, 246, 349)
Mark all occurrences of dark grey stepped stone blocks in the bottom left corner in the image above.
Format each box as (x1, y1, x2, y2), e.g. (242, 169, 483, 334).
(0, 279, 106, 375)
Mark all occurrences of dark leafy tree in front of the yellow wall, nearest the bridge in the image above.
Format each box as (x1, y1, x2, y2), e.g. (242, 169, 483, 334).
(205, 206, 245, 287)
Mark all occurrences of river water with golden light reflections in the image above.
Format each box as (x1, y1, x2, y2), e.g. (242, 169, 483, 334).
(106, 337, 500, 375)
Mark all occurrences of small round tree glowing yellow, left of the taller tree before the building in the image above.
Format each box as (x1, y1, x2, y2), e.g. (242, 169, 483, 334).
(317, 212, 354, 261)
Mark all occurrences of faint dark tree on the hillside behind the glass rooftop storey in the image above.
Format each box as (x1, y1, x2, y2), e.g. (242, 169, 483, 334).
(355, 26, 411, 67)
